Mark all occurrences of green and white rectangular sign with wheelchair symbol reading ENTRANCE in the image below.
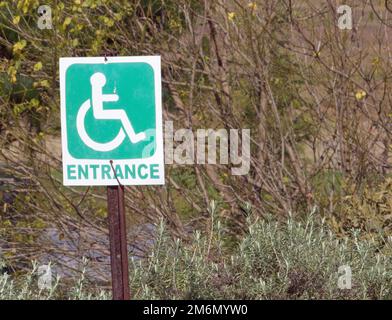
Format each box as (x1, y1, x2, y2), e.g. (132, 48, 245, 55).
(60, 56, 164, 186)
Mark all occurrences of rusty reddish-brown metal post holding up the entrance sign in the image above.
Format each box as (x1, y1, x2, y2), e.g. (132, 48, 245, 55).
(107, 185, 130, 300)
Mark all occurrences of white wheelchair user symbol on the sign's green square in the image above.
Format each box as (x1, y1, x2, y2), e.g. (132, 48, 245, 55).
(76, 72, 146, 152)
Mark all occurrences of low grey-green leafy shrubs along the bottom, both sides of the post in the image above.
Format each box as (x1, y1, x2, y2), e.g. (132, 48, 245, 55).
(0, 212, 392, 299)
